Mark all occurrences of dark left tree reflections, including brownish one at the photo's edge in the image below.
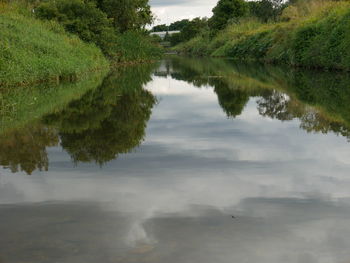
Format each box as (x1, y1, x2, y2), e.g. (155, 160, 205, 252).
(0, 65, 156, 174)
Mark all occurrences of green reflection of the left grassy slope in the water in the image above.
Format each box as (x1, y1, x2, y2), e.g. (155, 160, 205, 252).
(0, 68, 108, 134)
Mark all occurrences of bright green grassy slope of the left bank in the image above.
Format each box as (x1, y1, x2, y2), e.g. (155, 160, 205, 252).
(0, 4, 109, 86)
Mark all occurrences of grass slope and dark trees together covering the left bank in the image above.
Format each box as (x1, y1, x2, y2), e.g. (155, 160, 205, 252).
(0, 0, 162, 86)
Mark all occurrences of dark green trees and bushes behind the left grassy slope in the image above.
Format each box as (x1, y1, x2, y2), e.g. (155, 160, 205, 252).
(34, 0, 160, 62)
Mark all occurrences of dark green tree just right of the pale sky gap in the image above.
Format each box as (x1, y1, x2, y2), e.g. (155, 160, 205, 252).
(209, 0, 248, 34)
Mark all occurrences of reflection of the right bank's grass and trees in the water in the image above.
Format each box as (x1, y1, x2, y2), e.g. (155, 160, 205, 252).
(168, 58, 350, 139)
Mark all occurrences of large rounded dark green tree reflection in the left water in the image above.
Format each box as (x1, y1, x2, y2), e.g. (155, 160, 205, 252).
(44, 67, 156, 164)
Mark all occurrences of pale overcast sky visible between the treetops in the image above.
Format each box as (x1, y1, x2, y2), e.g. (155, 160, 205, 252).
(150, 0, 218, 25)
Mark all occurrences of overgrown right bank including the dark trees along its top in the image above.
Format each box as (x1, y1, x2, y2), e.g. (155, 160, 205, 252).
(170, 0, 350, 70)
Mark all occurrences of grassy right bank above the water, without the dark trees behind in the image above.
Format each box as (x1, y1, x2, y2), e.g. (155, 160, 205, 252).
(174, 0, 350, 70)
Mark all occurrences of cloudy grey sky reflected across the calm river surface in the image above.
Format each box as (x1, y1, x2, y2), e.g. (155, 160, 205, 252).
(0, 59, 350, 263)
